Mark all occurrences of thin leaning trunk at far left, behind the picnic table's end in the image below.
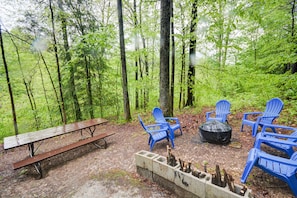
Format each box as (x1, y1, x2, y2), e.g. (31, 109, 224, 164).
(0, 24, 19, 135)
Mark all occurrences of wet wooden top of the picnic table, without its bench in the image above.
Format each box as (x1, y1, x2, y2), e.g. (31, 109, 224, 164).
(4, 118, 107, 149)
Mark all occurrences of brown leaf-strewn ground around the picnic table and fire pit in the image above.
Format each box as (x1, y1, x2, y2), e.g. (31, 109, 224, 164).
(0, 109, 293, 198)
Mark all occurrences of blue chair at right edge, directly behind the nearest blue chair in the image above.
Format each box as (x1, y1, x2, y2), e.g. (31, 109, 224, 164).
(254, 124, 297, 157)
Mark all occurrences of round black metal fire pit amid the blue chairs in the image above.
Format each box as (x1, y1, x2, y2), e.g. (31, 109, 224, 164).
(199, 120, 232, 144)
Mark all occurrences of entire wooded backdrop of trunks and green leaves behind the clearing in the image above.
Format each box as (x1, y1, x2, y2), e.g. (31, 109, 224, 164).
(0, 0, 297, 140)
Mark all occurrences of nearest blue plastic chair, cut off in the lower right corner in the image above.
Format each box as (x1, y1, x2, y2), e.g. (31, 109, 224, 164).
(240, 148, 297, 197)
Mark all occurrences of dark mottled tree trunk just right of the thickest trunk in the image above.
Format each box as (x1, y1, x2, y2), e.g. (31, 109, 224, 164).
(186, 0, 197, 106)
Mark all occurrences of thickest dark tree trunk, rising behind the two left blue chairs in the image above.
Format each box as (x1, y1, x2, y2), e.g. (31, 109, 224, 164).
(160, 0, 172, 116)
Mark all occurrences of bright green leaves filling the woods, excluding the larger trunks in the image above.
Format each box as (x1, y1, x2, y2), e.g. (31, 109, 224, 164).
(0, 0, 297, 143)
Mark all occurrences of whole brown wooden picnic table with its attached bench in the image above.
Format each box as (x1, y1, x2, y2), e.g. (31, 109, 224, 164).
(3, 118, 114, 178)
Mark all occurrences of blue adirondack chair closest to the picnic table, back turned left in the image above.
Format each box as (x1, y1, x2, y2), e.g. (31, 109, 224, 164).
(138, 115, 174, 151)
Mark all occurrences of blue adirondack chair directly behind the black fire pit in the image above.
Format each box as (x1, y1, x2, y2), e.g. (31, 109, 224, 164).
(206, 100, 231, 123)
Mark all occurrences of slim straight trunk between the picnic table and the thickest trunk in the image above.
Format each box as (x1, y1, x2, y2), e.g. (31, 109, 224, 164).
(117, 0, 131, 121)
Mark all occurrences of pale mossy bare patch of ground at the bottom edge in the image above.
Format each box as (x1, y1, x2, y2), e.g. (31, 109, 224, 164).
(71, 170, 175, 198)
